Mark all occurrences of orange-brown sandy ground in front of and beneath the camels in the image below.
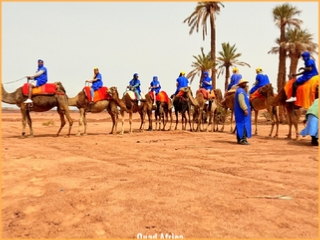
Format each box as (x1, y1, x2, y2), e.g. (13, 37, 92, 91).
(2, 111, 319, 238)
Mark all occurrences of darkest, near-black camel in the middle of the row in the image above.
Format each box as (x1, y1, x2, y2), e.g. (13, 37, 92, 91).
(171, 87, 192, 131)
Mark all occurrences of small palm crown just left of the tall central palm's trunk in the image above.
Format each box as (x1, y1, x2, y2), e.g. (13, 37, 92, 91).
(187, 47, 216, 85)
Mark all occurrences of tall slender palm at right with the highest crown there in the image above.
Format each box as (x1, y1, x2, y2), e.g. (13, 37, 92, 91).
(272, 3, 302, 122)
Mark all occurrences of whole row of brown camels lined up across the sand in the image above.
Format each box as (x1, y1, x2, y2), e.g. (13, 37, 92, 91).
(2, 76, 316, 139)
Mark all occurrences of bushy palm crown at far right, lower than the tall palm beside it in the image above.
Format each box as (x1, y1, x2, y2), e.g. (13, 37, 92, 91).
(268, 28, 318, 76)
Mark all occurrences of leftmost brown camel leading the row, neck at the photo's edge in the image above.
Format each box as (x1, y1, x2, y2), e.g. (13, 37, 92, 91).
(1, 82, 73, 138)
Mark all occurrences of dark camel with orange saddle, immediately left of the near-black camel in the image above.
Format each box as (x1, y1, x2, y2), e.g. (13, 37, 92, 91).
(154, 92, 172, 131)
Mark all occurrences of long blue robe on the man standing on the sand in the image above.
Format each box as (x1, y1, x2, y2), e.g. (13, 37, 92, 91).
(234, 88, 251, 139)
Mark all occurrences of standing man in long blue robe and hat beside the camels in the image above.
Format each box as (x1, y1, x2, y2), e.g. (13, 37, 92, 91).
(234, 79, 251, 145)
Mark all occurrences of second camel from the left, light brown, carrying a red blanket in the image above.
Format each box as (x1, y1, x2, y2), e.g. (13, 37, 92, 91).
(68, 91, 122, 136)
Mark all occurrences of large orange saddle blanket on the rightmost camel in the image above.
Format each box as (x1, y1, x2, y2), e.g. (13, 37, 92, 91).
(284, 75, 319, 109)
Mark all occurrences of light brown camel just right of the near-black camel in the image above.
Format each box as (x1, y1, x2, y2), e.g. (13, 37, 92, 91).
(187, 87, 217, 132)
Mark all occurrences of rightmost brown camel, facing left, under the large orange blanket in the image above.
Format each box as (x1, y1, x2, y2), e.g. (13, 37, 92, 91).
(259, 83, 301, 139)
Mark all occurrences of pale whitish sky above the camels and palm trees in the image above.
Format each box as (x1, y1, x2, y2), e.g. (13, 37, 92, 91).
(1, 2, 319, 107)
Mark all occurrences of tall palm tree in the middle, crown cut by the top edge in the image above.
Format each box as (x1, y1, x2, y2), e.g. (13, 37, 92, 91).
(183, 2, 224, 88)
